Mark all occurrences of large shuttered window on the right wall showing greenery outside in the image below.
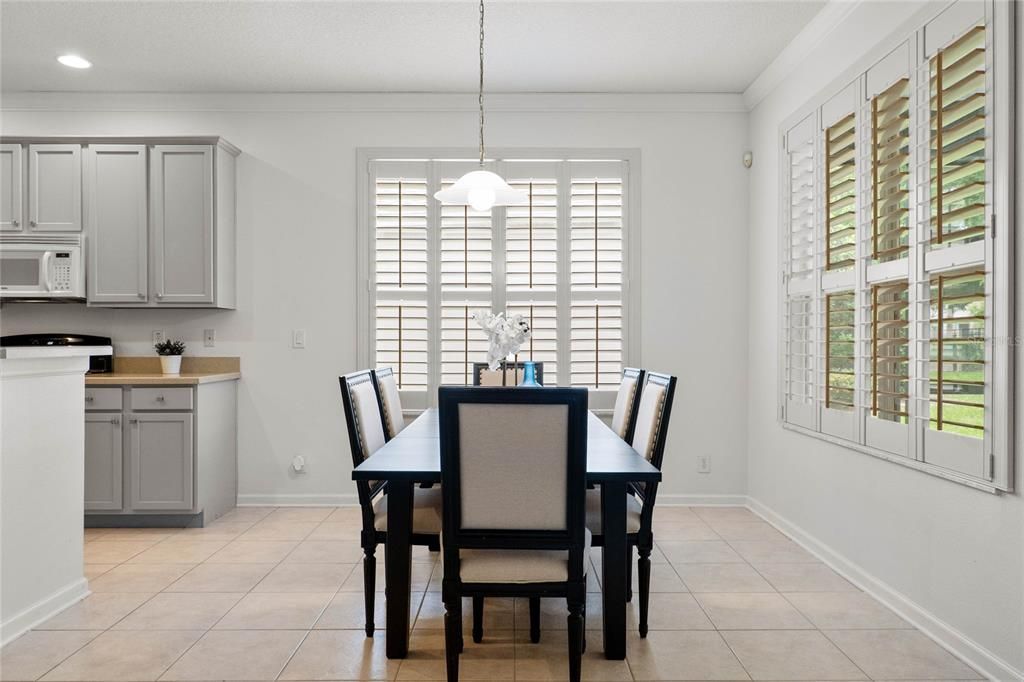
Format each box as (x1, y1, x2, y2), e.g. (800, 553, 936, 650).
(779, 0, 1013, 491)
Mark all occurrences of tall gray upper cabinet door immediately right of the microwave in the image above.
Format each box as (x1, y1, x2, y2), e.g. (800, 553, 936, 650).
(84, 144, 148, 303)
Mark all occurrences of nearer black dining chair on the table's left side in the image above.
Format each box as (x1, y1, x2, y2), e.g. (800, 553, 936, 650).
(338, 370, 441, 637)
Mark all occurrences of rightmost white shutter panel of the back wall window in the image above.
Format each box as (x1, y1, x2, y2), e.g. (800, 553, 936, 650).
(569, 162, 623, 389)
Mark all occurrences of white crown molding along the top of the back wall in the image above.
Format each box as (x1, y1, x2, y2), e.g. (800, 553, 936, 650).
(0, 92, 746, 114)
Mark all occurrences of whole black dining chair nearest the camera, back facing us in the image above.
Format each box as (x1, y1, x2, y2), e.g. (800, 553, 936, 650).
(438, 386, 590, 682)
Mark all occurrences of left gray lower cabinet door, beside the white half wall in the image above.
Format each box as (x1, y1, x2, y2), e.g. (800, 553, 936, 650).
(85, 413, 124, 511)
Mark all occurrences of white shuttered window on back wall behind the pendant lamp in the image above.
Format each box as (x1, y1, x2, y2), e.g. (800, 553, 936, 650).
(365, 155, 630, 410)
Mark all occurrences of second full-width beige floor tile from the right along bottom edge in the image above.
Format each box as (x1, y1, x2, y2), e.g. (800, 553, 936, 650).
(722, 630, 866, 680)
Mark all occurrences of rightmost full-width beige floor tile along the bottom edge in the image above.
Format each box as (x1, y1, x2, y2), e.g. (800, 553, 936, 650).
(825, 630, 979, 680)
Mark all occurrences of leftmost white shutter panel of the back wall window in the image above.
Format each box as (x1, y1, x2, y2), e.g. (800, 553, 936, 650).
(374, 162, 428, 391)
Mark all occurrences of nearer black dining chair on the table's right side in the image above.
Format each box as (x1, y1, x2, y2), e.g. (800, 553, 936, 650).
(587, 372, 676, 637)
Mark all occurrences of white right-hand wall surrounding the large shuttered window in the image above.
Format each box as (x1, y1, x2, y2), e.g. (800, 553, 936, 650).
(748, 3, 1024, 679)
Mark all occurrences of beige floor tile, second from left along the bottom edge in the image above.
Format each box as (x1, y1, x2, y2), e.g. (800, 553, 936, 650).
(43, 631, 202, 682)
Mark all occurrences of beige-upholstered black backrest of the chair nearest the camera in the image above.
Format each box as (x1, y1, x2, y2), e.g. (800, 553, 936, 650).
(438, 386, 587, 581)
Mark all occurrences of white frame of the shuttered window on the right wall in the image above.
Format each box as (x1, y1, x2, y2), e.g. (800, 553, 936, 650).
(776, 0, 1016, 494)
